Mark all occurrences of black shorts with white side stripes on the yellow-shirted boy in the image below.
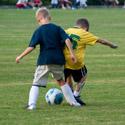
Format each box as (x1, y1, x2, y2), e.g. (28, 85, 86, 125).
(64, 66, 87, 82)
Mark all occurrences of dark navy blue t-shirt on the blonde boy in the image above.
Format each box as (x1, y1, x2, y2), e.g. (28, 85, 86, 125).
(29, 23, 69, 65)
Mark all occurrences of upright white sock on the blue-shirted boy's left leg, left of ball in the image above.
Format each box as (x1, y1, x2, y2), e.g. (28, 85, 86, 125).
(28, 86, 39, 106)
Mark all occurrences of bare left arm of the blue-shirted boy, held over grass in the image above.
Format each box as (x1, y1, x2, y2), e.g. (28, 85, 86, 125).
(16, 47, 34, 63)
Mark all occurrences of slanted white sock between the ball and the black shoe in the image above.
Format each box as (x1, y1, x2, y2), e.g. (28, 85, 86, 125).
(61, 84, 76, 105)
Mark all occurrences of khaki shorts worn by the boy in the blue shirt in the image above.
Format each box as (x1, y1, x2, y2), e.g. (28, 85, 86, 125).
(33, 65, 64, 87)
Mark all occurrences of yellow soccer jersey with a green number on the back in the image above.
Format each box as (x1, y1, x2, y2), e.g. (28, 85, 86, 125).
(64, 27, 99, 70)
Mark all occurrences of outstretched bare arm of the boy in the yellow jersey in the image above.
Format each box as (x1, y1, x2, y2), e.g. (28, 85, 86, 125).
(96, 39, 118, 49)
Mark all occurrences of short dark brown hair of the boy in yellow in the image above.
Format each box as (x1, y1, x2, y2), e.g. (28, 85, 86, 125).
(76, 18, 89, 31)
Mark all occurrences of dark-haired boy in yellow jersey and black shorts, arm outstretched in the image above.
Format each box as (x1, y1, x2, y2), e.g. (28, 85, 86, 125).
(64, 18, 117, 105)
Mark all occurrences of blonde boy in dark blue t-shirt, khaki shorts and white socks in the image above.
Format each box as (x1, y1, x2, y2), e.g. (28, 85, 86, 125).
(16, 7, 81, 110)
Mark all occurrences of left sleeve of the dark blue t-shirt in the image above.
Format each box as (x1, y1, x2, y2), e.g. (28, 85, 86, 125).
(29, 29, 40, 48)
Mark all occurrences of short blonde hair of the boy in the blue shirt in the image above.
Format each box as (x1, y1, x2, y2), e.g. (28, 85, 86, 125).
(36, 7, 50, 19)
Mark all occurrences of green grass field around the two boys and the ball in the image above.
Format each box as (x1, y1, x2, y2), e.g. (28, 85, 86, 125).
(0, 8, 125, 125)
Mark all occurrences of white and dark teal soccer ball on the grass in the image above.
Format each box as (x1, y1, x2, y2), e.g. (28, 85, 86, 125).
(45, 88, 63, 105)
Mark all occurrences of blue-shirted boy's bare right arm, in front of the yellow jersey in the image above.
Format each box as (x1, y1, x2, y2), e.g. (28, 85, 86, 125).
(65, 39, 77, 63)
